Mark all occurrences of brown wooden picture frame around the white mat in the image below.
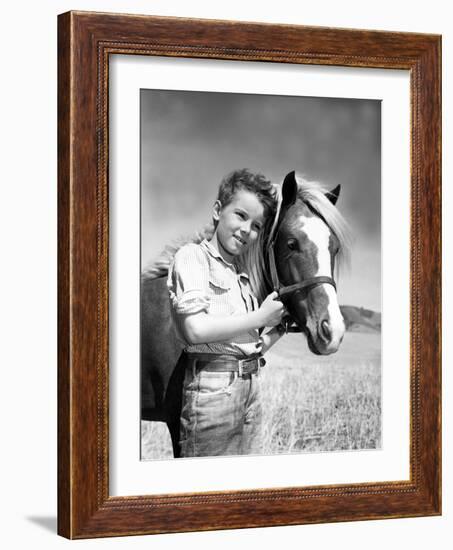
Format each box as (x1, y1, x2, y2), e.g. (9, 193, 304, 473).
(58, 12, 441, 538)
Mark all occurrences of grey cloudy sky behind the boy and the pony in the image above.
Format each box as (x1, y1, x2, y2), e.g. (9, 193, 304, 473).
(140, 90, 381, 311)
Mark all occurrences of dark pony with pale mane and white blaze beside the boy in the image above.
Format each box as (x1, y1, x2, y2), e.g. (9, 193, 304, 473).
(141, 171, 350, 457)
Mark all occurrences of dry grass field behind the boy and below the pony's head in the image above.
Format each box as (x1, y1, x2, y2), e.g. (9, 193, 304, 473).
(142, 332, 381, 460)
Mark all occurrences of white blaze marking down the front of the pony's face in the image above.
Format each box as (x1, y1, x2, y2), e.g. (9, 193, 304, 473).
(301, 217, 344, 345)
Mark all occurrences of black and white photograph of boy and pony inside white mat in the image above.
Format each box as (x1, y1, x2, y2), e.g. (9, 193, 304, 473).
(140, 89, 382, 460)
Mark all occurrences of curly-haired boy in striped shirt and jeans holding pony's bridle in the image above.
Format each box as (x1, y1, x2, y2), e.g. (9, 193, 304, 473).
(168, 169, 285, 457)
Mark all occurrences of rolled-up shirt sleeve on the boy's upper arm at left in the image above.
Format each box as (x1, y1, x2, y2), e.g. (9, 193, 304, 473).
(167, 244, 209, 315)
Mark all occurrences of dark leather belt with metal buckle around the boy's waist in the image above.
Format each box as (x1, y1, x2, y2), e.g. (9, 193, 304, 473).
(186, 353, 266, 377)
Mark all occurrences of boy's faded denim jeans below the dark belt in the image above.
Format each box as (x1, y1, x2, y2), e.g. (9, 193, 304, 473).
(180, 358, 262, 457)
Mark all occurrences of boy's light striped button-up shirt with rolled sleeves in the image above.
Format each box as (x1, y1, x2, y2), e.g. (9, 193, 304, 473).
(167, 239, 263, 356)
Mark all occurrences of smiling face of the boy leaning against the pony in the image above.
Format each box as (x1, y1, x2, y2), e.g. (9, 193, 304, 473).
(213, 189, 264, 261)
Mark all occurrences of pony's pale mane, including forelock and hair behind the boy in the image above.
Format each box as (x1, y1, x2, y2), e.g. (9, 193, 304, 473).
(142, 175, 351, 303)
